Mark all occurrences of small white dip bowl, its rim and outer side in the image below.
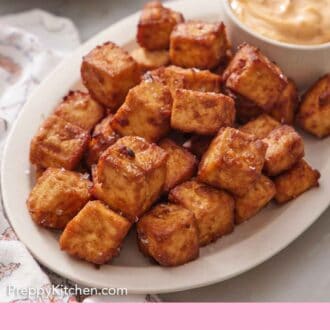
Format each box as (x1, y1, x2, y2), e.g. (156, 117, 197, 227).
(221, 0, 330, 90)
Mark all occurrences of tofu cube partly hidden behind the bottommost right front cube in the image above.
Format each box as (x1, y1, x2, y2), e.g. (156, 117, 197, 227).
(169, 180, 235, 246)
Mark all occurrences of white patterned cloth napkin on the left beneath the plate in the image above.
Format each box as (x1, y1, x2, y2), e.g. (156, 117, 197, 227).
(0, 10, 157, 302)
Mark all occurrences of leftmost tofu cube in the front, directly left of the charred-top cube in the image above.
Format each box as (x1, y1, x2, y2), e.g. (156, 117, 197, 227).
(27, 167, 92, 229)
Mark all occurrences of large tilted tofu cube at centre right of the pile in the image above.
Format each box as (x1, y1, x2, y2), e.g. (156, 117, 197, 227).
(198, 127, 267, 196)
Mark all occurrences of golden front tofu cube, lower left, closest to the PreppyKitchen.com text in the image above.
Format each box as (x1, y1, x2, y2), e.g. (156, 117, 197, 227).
(60, 201, 132, 265)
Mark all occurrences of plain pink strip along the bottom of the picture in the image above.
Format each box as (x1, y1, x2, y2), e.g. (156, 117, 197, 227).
(0, 303, 330, 330)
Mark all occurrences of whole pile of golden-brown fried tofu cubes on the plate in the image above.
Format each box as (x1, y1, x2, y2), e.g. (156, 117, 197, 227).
(27, 2, 330, 266)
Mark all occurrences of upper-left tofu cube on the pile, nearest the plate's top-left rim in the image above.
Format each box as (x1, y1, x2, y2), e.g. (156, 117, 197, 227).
(81, 42, 141, 111)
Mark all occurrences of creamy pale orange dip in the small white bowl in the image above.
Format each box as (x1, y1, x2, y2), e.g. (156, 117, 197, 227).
(226, 0, 330, 45)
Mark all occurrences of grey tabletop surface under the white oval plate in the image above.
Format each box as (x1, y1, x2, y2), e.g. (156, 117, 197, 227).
(0, 0, 330, 301)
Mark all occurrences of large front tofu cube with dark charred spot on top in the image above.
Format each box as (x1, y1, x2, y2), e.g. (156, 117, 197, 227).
(93, 136, 167, 220)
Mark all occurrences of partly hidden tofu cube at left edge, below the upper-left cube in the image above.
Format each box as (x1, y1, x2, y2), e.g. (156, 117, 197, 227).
(55, 91, 105, 131)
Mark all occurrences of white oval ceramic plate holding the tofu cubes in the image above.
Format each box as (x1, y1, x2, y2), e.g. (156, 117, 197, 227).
(1, 0, 330, 293)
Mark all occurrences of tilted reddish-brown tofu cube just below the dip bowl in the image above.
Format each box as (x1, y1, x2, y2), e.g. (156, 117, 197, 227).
(223, 43, 288, 111)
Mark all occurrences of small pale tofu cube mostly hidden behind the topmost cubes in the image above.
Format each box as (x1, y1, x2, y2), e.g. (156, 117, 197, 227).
(131, 47, 170, 71)
